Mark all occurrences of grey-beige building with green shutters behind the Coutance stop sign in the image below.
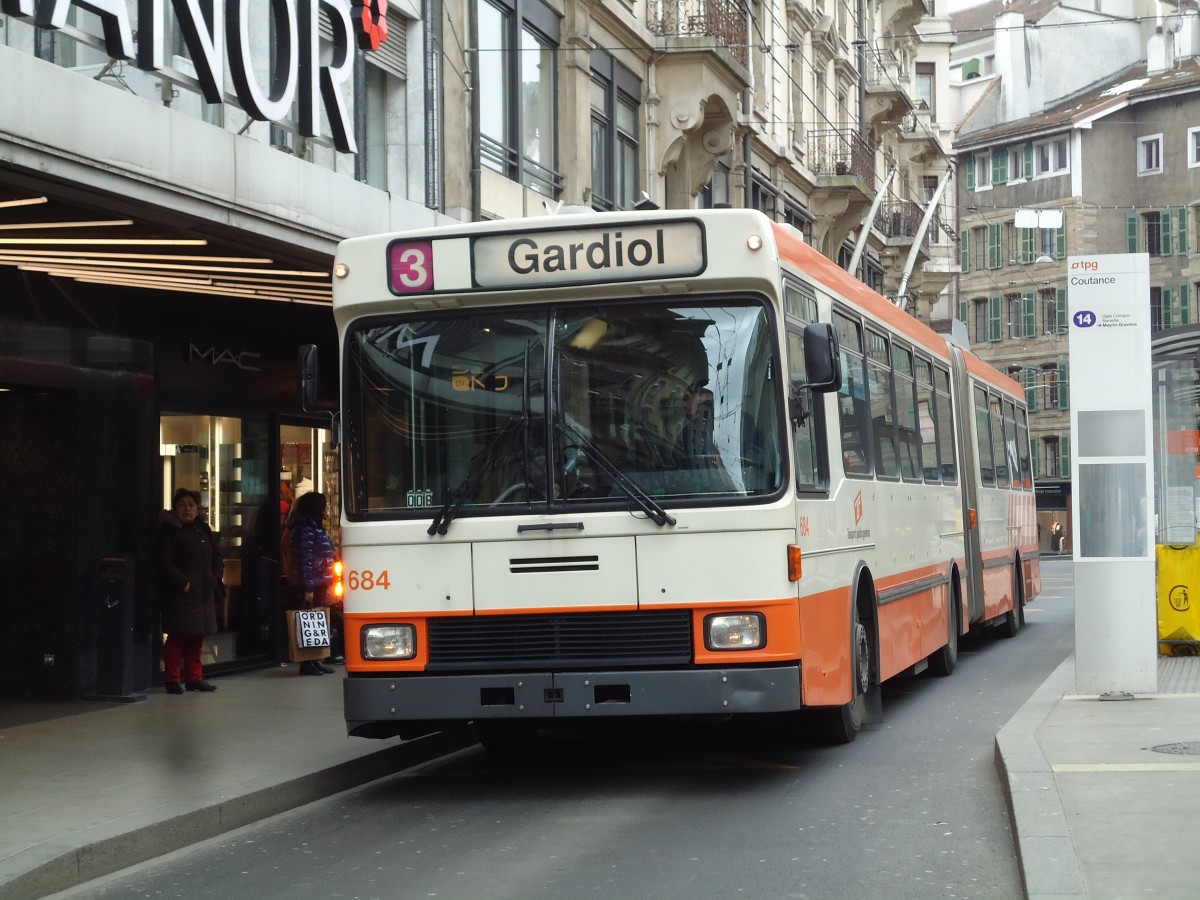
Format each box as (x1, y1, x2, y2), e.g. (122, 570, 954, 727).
(954, 4, 1200, 550)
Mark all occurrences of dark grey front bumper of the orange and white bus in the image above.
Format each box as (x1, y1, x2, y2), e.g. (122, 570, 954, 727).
(342, 665, 800, 733)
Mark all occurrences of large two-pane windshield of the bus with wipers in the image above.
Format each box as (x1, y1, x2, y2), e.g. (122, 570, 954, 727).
(343, 298, 784, 520)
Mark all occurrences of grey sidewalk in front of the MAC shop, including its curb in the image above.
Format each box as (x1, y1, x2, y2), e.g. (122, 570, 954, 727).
(0, 665, 462, 900)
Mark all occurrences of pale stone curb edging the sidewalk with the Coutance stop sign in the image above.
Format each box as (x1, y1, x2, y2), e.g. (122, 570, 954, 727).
(995, 654, 1087, 900)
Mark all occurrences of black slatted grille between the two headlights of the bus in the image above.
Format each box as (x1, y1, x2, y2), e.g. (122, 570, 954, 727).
(428, 610, 691, 670)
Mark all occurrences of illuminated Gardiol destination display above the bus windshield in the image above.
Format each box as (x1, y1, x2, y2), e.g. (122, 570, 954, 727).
(472, 221, 707, 288)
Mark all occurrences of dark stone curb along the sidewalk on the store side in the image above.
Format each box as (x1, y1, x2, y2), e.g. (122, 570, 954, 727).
(0, 732, 470, 900)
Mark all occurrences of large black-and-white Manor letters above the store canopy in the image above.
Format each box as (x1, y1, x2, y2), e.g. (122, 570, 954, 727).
(0, 0, 388, 154)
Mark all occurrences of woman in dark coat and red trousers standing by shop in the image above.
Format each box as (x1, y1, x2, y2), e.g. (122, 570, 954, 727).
(156, 487, 224, 694)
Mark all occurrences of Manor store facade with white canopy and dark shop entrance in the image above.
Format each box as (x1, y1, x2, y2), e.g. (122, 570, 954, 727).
(0, 0, 446, 698)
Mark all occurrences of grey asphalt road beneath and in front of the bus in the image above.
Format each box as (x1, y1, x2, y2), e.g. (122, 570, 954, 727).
(54, 563, 1074, 900)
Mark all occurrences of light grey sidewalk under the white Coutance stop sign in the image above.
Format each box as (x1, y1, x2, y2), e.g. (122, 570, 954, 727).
(996, 655, 1200, 900)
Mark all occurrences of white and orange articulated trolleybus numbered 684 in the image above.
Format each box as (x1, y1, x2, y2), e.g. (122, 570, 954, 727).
(334, 210, 1040, 746)
